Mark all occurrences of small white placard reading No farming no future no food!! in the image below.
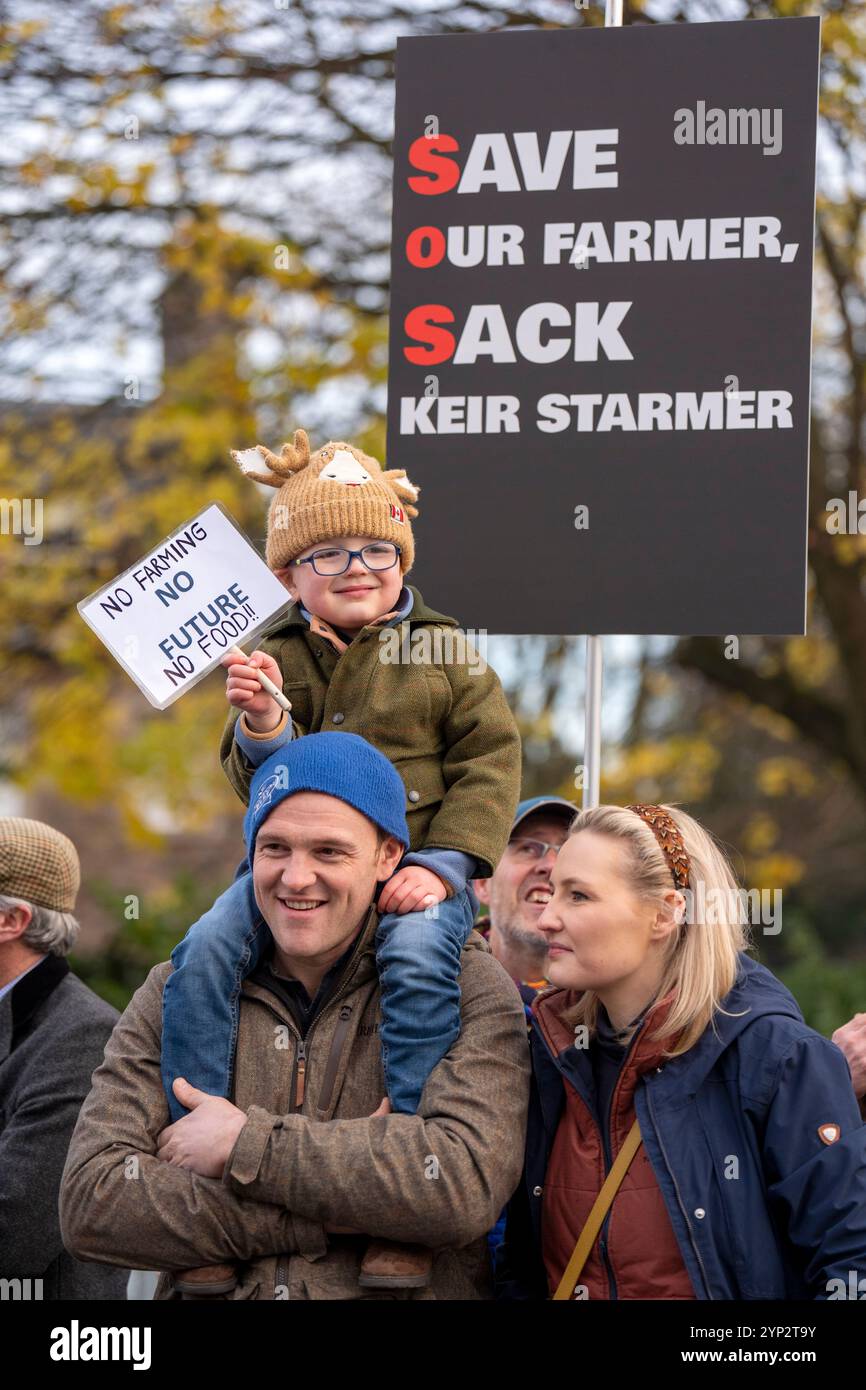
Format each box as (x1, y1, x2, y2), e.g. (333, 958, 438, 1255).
(78, 502, 292, 709)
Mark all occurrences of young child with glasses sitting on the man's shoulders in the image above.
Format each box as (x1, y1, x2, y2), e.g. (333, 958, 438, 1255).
(161, 430, 521, 1287)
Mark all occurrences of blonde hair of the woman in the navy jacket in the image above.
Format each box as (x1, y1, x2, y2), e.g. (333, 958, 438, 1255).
(569, 806, 749, 1056)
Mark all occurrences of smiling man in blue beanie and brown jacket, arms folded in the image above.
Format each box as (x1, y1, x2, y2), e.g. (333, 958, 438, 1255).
(60, 733, 528, 1300)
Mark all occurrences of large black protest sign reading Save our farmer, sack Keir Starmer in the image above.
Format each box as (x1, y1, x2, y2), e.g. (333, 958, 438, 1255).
(388, 19, 820, 634)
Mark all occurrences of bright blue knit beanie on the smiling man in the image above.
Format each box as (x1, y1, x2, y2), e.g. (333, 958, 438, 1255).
(243, 733, 409, 859)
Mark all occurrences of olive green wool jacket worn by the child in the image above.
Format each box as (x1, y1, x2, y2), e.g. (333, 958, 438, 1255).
(220, 585, 521, 874)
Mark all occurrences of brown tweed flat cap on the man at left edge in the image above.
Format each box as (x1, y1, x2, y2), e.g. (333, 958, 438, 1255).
(0, 816, 81, 912)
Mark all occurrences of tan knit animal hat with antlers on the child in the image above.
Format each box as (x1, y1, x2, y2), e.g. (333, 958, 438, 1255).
(232, 430, 418, 574)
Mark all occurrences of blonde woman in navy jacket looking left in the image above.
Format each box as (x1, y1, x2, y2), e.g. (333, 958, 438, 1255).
(498, 805, 866, 1300)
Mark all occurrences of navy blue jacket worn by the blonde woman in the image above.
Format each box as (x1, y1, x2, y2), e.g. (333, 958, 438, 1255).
(496, 954, 866, 1300)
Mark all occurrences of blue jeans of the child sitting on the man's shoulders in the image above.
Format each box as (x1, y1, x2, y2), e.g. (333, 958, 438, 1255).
(161, 860, 478, 1122)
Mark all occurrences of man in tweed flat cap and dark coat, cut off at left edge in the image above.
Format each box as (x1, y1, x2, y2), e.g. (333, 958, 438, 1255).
(0, 817, 128, 1300)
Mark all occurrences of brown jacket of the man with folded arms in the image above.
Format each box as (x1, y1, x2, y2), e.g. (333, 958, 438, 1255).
(60, 908, 530, 1300)
